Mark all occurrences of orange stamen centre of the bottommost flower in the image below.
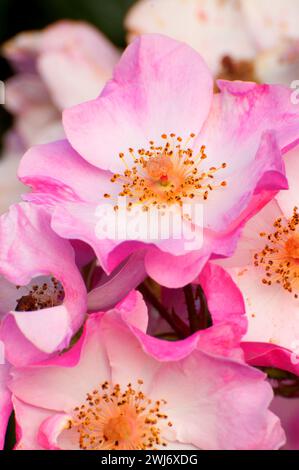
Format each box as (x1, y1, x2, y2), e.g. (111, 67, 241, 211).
(69, 380, 172, 450)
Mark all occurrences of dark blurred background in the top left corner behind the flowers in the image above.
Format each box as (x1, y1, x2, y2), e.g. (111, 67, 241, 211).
(0, 0, 134, 149)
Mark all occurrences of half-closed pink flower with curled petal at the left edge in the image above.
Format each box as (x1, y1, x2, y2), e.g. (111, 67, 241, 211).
(0, 203, 87, 365)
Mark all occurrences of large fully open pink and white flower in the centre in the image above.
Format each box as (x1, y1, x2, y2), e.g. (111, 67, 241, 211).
(19, 35, 299, 287)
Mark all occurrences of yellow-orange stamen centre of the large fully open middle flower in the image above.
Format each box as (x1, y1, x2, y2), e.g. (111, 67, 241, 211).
(104, 134, 227, 210)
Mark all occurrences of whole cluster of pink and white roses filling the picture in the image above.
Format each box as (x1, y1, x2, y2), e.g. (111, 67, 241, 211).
(0, 0, 299, 450)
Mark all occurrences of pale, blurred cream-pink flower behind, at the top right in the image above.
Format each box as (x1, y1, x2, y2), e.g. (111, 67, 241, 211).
(125, 0, 299, 85)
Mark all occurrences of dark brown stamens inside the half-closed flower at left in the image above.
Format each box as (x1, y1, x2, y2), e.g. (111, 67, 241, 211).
(16, 277, 64, 312)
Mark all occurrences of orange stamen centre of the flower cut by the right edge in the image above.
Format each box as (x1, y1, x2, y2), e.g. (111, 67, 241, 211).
(254, 207, 299, 298)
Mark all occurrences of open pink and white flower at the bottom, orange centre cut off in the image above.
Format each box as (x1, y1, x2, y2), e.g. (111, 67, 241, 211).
(10, 294, 284, 450)
